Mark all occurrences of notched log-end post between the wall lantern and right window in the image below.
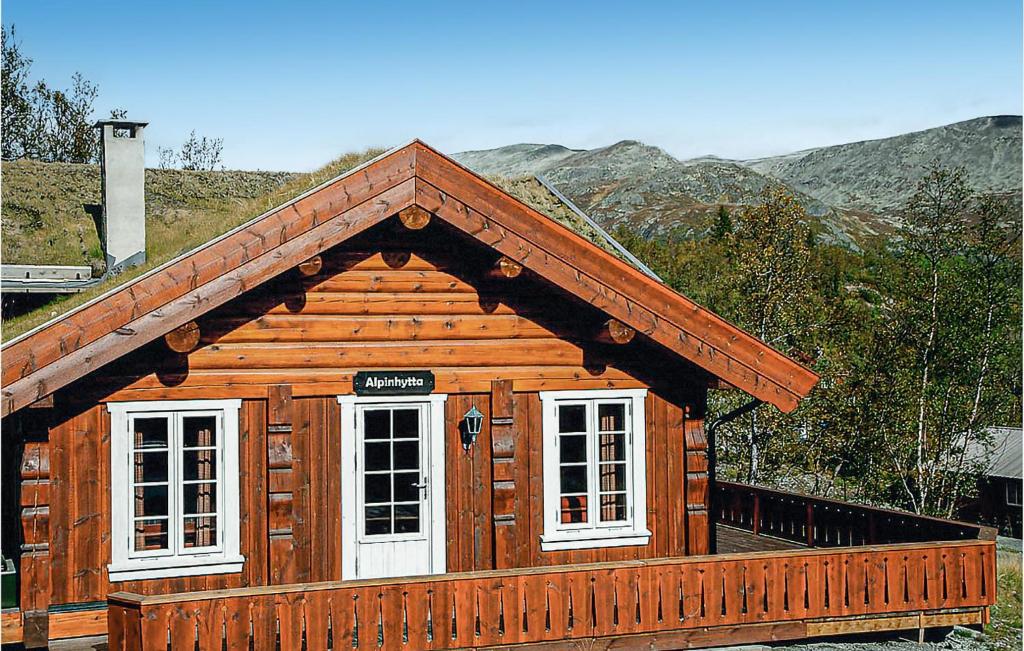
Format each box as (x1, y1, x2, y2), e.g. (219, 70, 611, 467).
(490, 380, 517, 569)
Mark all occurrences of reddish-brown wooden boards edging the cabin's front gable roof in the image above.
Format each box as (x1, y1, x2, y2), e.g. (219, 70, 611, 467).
(0, 140, 818, 416)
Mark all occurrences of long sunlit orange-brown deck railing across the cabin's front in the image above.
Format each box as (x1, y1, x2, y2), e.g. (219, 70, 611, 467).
(109, 540, 995, 651)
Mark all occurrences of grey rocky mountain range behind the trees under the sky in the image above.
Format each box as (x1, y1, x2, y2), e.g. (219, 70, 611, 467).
(455, 116, 1022, 246)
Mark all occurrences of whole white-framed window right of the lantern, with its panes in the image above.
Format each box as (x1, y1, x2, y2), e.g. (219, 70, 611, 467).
(541, 389, 650, 552)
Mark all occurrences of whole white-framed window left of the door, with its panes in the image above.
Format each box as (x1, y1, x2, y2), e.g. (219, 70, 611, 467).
(108, 400, 245, 581)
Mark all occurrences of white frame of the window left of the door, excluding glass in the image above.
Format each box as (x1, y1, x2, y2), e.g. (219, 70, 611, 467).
(106, 399, 245, 581)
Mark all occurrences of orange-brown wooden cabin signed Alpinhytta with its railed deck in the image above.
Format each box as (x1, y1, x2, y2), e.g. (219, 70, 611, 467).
(2, 141, 995, 651)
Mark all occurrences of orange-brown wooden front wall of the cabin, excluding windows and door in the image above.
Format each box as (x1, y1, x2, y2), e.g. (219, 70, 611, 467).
(9, 219, 708, 609)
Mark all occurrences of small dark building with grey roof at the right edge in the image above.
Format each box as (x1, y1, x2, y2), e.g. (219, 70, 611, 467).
(959, 427, 1024, 538)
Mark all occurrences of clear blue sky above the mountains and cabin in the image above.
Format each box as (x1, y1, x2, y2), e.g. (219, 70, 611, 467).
(2, 0, 1024, 171)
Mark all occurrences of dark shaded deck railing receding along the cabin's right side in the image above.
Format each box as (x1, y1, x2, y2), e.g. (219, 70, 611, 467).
(714, 481, 995, 547)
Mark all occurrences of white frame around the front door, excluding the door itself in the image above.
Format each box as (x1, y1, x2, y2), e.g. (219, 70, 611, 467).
(338, 393, 447, 580)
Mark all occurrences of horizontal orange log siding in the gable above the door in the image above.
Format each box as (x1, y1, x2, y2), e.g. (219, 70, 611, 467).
(88, 224, 706, 400)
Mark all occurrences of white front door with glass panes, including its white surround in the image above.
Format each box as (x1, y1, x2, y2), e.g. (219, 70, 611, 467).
(342, 396, 444, 579)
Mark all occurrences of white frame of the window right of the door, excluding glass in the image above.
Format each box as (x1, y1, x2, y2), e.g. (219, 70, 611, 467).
(540, 389, 651, 552)
